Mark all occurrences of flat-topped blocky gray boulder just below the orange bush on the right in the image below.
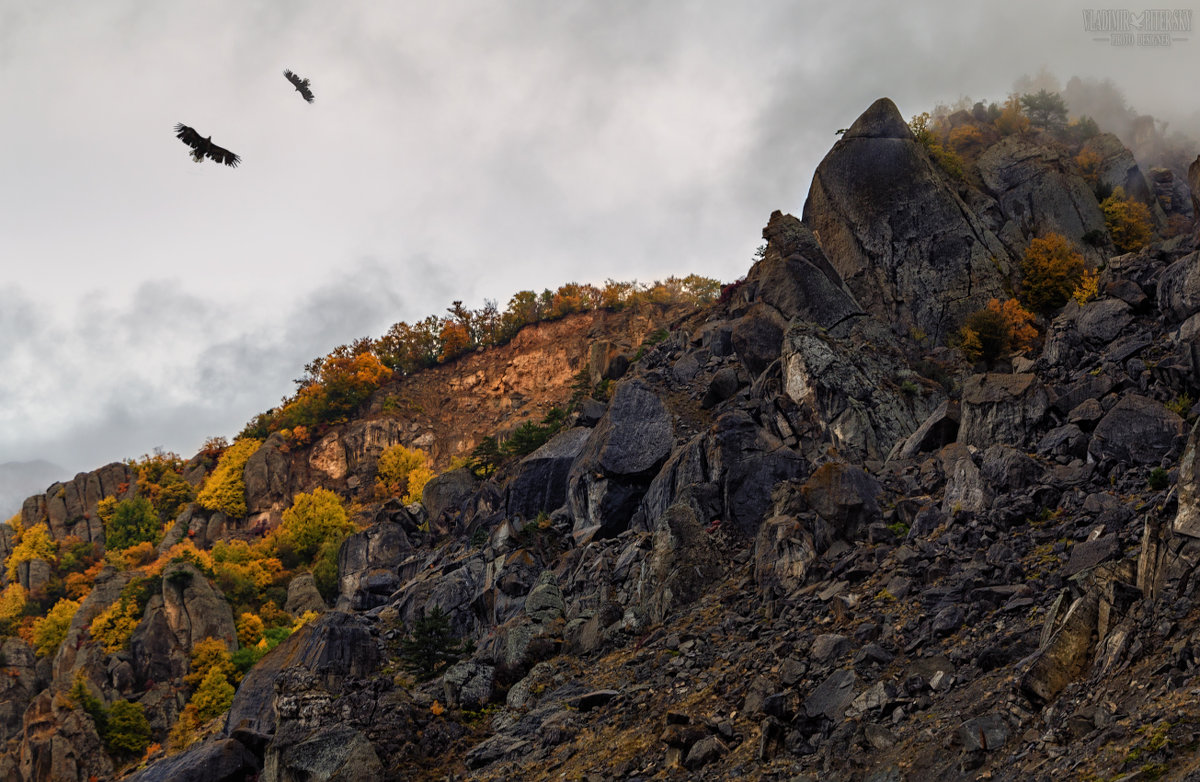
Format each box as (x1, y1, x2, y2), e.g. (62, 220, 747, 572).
(959, 374, 1050, 449)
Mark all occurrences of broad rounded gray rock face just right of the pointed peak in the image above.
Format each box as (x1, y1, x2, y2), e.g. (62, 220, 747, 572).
(978, 136, 1104, 254)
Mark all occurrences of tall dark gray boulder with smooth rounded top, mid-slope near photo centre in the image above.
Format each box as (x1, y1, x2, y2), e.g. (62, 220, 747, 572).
(568, 380, 674, 537)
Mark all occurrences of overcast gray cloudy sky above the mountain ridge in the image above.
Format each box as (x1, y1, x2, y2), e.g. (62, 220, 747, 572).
(0, 0, 1200, 489)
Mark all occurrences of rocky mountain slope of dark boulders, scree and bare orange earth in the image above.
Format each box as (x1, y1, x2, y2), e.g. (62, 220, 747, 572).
(0, 98, 1200, 782)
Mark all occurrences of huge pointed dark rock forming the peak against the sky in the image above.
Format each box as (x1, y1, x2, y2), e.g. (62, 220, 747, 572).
(804, 98, 1012, 343)
